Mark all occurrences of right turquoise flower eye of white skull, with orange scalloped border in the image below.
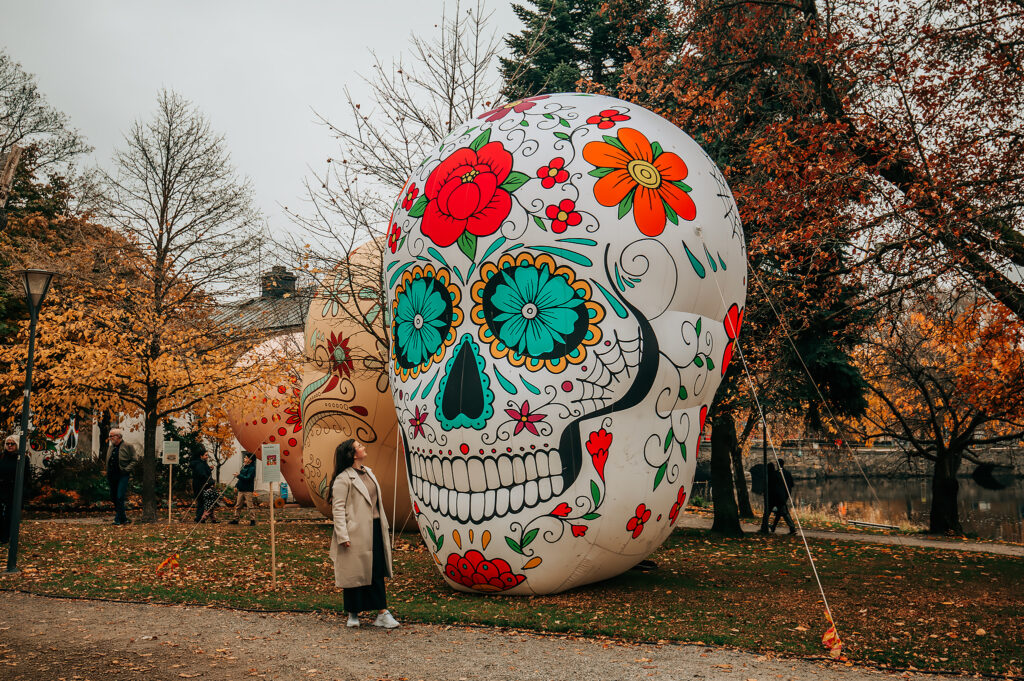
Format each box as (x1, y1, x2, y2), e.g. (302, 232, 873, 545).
(471, 253, 604, 374)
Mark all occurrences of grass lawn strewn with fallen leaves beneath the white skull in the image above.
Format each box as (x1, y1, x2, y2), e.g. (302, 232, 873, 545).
(0, 521, 1024, 675)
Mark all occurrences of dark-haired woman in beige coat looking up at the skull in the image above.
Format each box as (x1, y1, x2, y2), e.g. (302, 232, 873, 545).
(328, 439, 398, 629)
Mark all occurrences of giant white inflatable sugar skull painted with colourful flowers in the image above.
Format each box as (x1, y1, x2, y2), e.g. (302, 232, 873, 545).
(384, 93, 746, 594)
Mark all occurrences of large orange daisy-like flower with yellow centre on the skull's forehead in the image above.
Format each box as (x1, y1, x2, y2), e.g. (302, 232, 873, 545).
(583, 128, 697, 237)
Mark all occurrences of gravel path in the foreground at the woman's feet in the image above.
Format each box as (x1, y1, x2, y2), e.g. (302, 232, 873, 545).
(0, 592, 967, 681)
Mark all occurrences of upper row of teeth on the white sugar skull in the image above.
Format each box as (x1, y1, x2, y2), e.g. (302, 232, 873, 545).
(410, 452, 562, 494)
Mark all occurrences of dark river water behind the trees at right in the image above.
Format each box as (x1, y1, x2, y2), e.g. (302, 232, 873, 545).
(778, 478, 1024, 542)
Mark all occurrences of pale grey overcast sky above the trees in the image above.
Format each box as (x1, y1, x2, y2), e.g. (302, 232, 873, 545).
(0, 0, 520, 246)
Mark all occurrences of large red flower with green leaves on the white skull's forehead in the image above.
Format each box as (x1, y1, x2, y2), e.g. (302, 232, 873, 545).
(422, 142, 512, 247)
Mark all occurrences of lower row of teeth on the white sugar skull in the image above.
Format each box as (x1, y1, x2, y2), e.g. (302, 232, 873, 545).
(413, 475, 563, 522)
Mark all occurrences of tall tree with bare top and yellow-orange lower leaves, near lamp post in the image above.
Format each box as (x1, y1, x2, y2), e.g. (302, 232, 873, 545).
(92, 90, 262, 519)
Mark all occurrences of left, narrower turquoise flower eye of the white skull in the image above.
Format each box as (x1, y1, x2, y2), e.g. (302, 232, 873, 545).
(391, 265, 462, 381)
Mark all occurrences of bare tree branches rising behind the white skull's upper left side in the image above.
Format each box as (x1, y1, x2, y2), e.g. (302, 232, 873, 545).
(279, 0, 501, 358)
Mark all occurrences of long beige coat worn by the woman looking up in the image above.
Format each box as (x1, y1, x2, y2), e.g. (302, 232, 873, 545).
(331, 466, 392, 589)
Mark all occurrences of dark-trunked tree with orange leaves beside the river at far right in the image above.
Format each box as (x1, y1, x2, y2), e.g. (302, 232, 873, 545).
(857, 292, 1024, 534)
